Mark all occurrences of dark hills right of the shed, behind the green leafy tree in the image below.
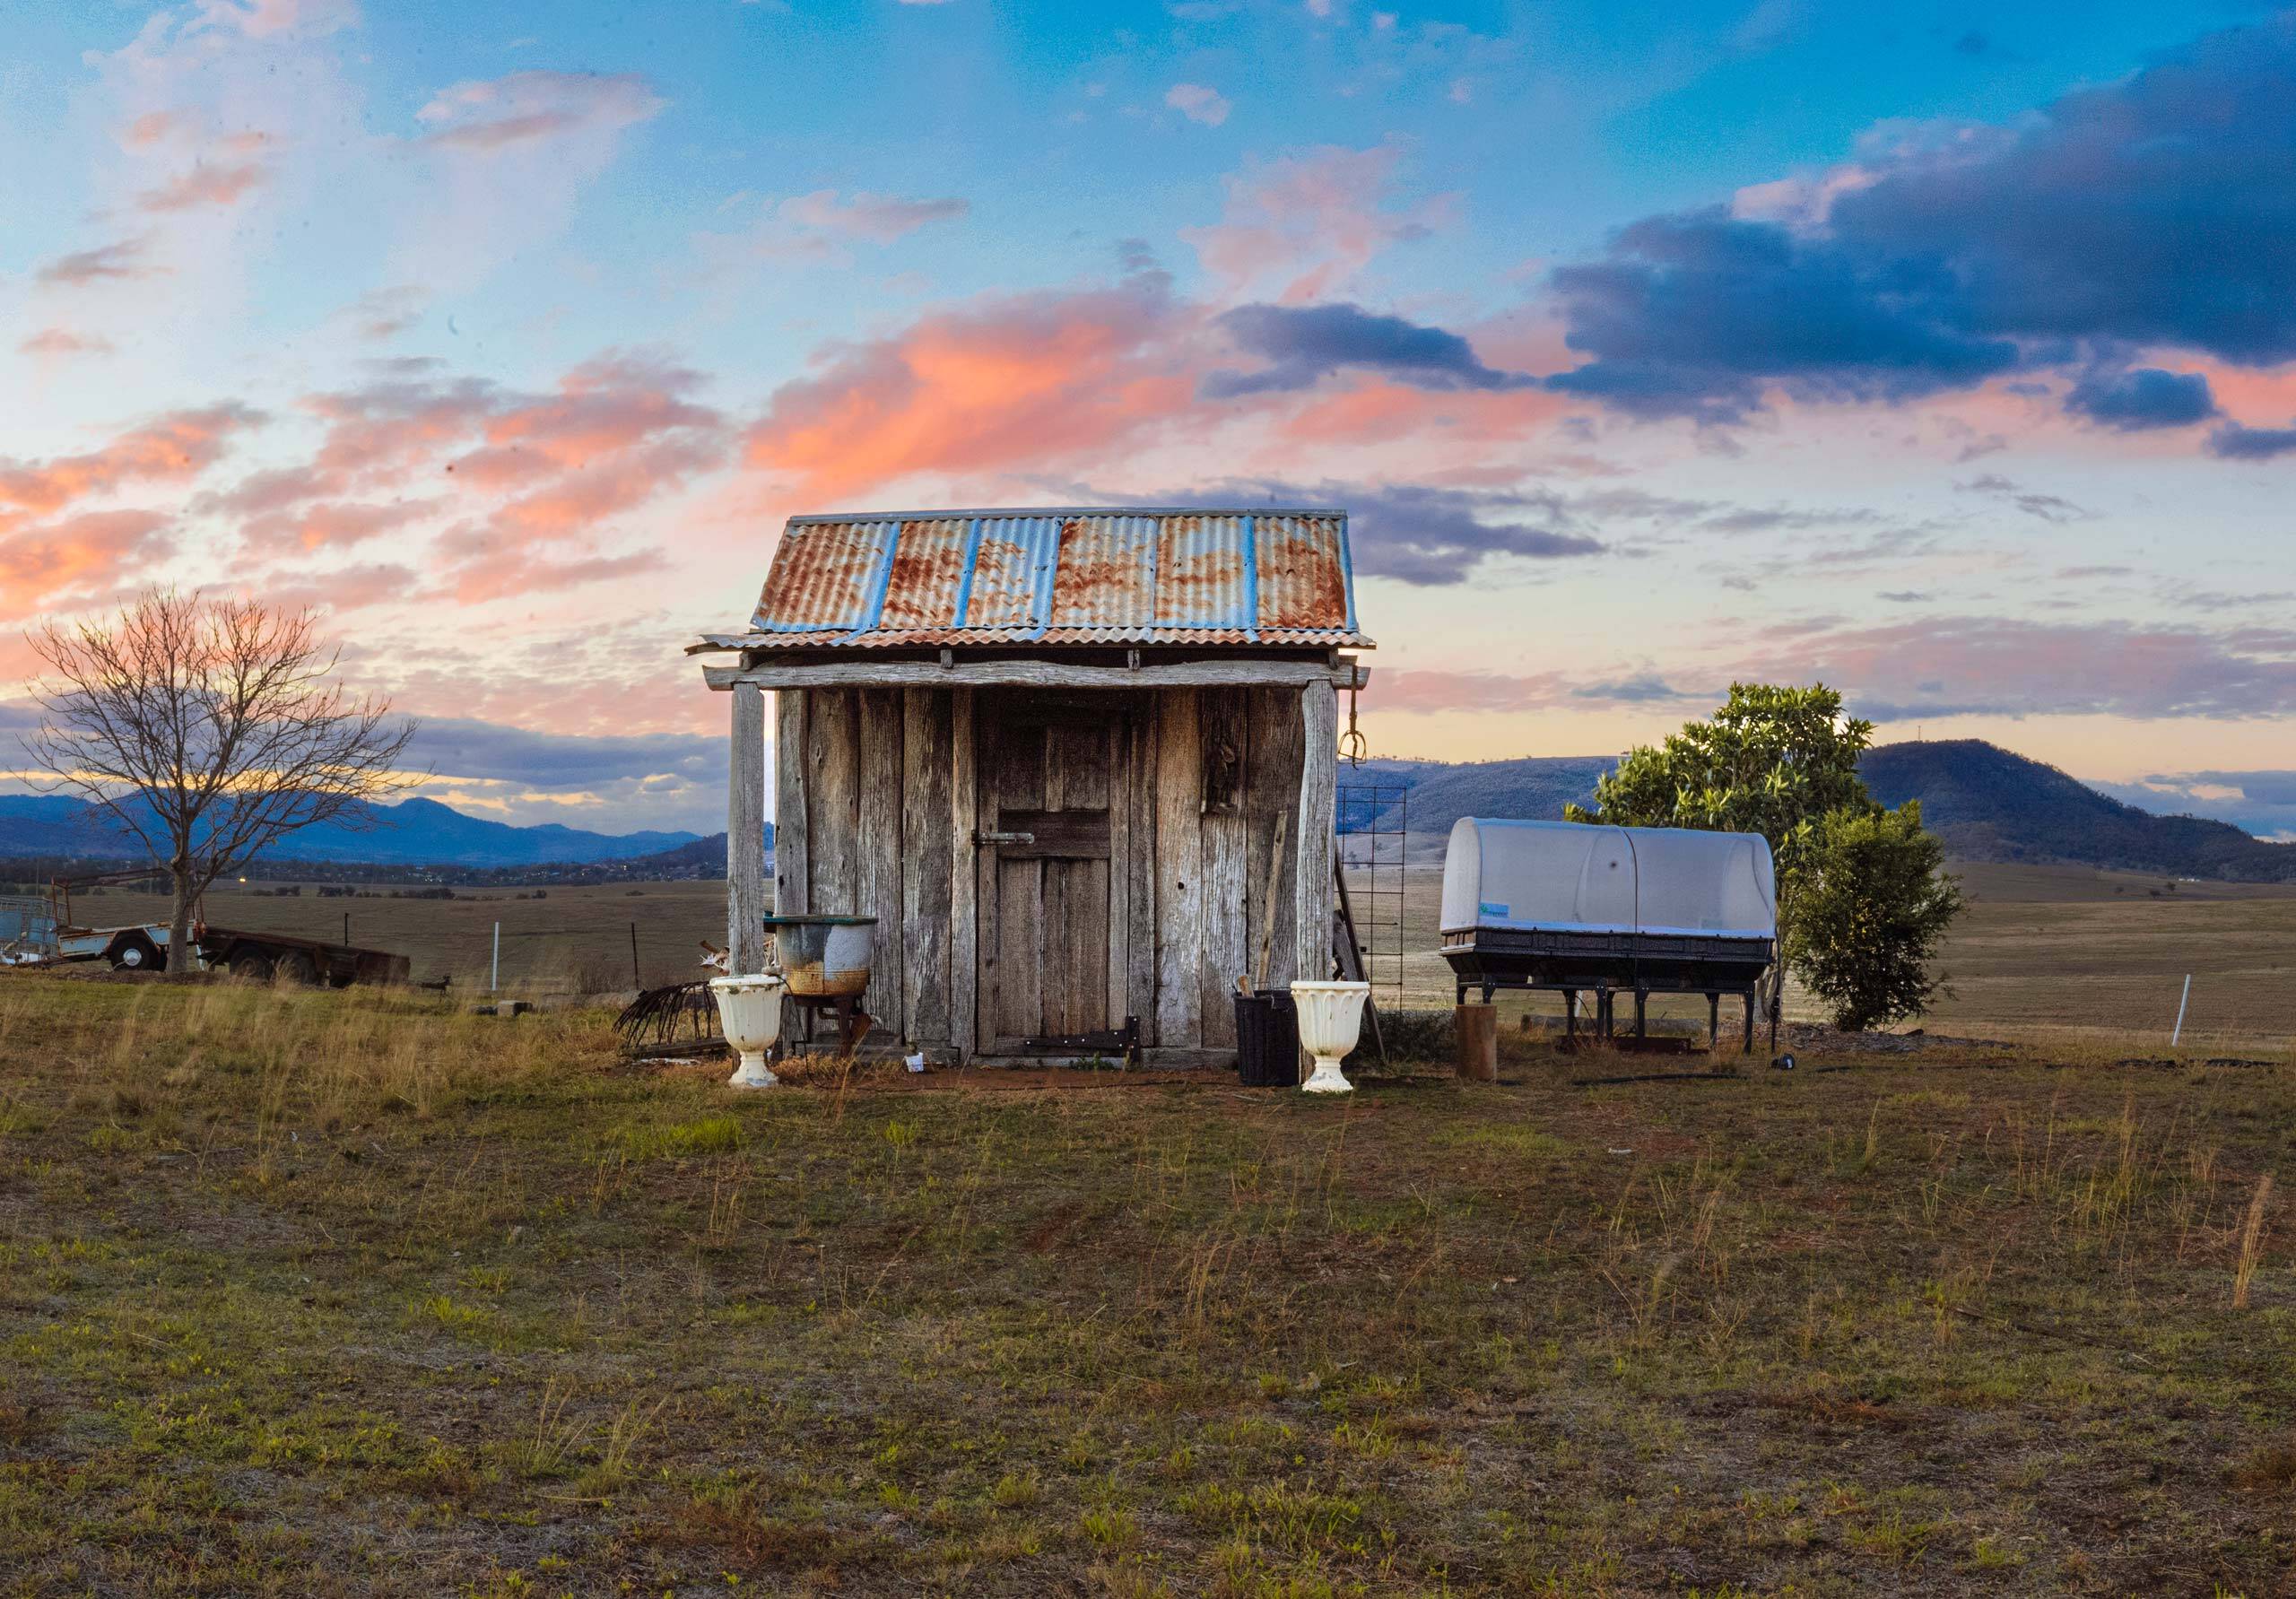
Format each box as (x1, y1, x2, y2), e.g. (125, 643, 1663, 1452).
(1338, 737, 2296, 882)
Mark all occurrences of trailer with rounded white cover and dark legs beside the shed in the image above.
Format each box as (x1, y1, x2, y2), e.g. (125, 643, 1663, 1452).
(1442, 818, 1777, 1050)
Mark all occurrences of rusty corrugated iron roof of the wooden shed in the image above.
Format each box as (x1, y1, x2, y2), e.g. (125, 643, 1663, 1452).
(702, 506, 1370, 647)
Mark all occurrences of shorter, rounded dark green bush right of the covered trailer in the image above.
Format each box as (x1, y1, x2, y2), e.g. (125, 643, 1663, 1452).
(1784, 800, 1961, 1030)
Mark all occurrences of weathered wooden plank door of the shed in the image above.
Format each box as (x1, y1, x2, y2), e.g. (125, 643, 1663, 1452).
(973, 694, 1127, 1055)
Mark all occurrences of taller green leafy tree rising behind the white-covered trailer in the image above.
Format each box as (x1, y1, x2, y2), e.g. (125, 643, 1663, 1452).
(1563, 682, 1959, 1025)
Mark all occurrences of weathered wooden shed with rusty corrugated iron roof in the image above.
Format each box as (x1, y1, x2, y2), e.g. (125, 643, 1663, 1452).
(693, 508, 1370, 1064)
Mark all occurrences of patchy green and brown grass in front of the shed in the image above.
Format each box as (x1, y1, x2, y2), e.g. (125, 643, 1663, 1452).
(0, 974, 2296, 1595)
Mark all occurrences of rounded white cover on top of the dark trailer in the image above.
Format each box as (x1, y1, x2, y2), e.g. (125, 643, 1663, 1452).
(1442, 815, 1777, 940)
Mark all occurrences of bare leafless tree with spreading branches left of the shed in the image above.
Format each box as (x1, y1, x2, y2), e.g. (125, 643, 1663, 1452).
(25, 590, 415, 972)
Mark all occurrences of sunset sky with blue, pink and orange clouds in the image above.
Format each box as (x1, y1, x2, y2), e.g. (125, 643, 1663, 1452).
(0, 0, 2296, 831)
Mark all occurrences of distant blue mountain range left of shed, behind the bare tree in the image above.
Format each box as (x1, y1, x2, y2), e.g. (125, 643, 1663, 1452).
(0, 795, 723, 866)
